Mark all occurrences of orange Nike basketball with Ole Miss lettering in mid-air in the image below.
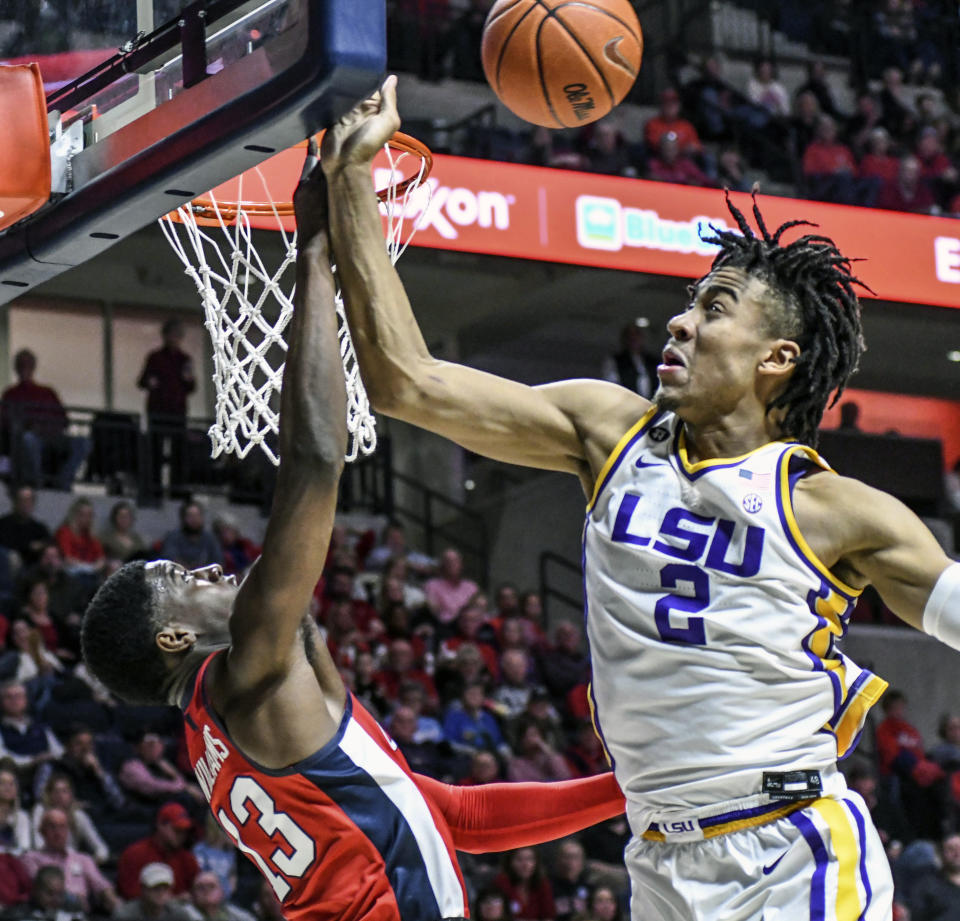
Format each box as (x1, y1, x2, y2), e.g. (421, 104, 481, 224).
(481, 0, 643, 128)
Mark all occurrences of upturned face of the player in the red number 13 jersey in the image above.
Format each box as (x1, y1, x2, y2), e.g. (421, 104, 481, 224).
(146, 560, 244, 642)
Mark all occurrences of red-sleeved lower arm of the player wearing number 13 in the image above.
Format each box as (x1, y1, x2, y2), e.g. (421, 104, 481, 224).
(414, 774, 625, 854)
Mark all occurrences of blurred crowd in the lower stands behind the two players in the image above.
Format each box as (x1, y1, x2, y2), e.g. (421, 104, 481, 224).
(0, 486, 960, 921)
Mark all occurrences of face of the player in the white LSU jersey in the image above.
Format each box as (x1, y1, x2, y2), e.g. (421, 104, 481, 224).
(654, 268, 777, 424)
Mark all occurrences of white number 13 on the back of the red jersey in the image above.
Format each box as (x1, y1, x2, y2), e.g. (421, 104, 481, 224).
(217, 777, 317, 901)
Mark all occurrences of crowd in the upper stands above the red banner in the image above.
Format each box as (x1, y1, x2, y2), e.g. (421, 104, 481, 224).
(388, 0, 960, 214)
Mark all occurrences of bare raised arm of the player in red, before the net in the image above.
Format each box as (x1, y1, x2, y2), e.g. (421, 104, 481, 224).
(223, 147, 347, 693)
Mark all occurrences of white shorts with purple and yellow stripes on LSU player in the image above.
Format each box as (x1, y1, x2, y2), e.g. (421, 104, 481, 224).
(626, 791, 893, 921)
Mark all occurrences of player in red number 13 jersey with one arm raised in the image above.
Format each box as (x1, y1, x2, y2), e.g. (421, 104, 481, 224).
(82, 138, 623, 921)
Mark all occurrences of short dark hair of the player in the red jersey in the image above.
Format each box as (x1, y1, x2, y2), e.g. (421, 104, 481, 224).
(80, 560, 170, 704)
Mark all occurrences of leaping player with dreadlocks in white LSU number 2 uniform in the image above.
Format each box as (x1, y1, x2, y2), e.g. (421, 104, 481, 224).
(323, 80, 960, 921)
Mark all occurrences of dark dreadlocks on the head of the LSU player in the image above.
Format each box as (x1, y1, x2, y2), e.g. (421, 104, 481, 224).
(701, 191, 872, 447)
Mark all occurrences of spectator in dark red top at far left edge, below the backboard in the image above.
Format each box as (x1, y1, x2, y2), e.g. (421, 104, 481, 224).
(0, 349, 90, 492)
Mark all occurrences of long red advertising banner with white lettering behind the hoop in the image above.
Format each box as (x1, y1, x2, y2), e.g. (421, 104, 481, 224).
(215, 150, 960, 308)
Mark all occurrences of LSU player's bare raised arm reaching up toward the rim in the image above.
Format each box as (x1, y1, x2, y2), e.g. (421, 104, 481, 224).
(322, 77, 648, 490)
